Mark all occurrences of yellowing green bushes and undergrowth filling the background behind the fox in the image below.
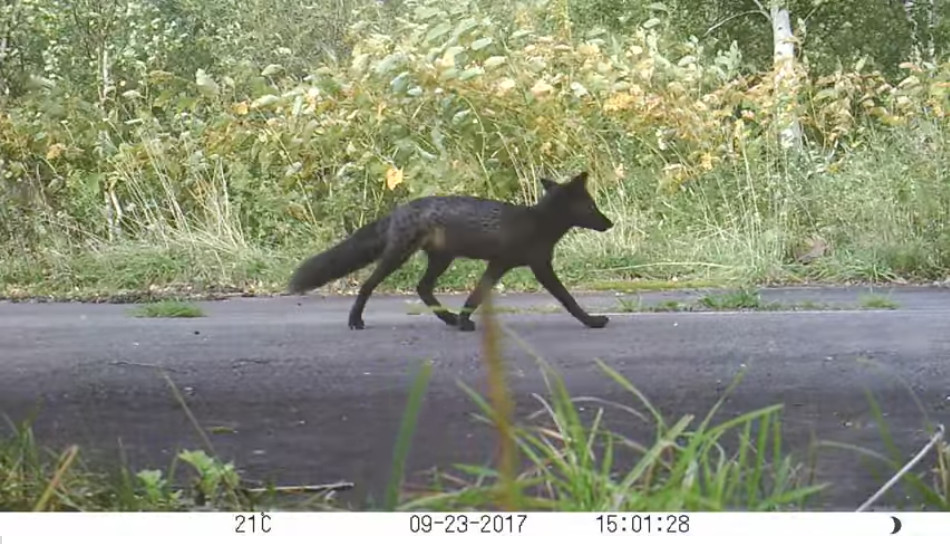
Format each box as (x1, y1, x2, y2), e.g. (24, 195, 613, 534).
(0, 0, 950, 294)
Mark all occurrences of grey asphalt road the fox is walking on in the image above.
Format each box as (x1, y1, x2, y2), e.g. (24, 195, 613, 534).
(0, 288, 950, 510)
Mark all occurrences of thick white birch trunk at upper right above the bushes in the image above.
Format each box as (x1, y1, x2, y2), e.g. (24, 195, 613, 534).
(770, 0, 802, 149)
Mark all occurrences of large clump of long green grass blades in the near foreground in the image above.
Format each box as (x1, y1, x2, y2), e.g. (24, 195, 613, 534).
(394, 296, 824, 511)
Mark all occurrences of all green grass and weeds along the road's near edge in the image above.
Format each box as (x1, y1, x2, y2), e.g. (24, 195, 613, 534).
(0, 298, 950, 511)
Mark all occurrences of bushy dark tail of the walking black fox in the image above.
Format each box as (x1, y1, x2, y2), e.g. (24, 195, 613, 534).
(288, 217, 389, 294)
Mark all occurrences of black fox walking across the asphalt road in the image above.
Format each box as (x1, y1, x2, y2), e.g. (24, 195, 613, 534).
(289, 172, 613, 331)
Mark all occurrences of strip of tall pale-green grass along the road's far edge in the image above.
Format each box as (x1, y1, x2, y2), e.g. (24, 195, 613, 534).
(0, 120, 950, 302)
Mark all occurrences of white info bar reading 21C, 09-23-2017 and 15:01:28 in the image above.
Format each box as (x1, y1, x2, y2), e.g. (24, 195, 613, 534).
(0, 511, 950, 544)
